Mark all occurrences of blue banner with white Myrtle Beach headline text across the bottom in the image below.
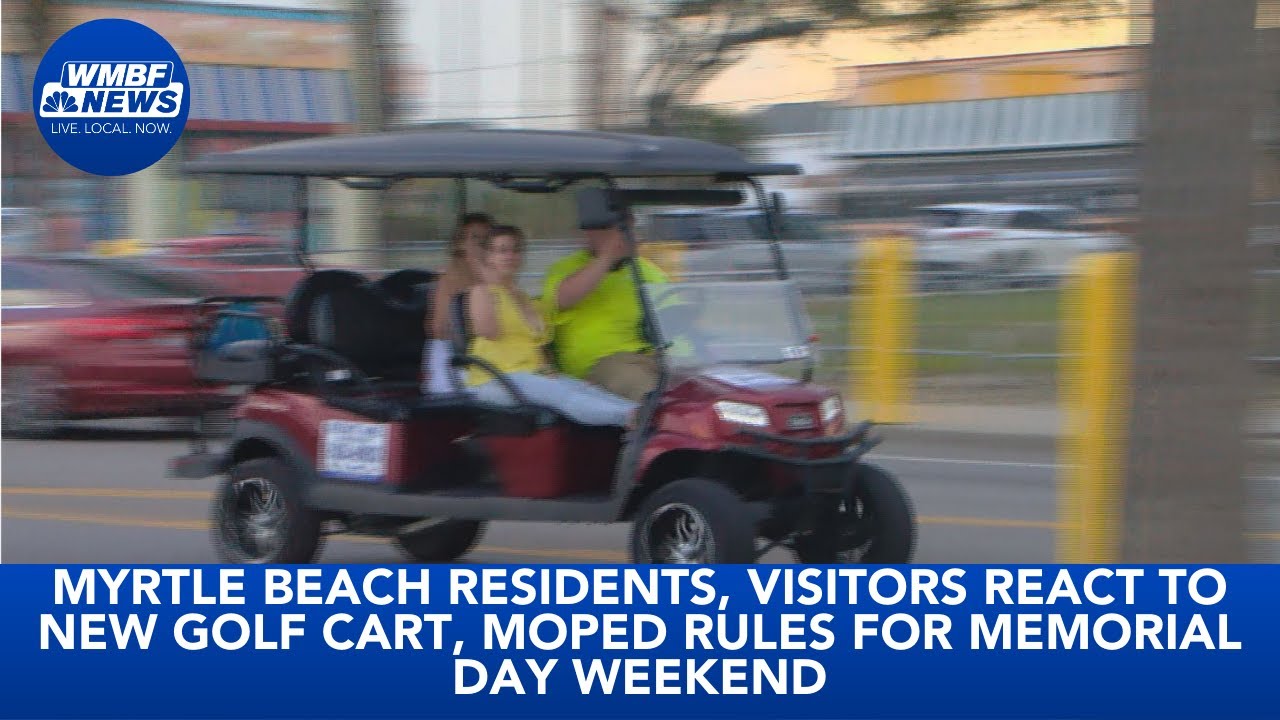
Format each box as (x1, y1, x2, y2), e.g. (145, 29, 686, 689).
(0, 565, 1280, 719)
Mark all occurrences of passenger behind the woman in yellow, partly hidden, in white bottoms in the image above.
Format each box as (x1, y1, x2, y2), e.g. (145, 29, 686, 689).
(422, 213, 493, 395)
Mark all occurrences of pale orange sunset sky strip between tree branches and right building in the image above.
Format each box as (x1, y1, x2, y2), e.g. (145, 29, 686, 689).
(701, 11, 1129, 109)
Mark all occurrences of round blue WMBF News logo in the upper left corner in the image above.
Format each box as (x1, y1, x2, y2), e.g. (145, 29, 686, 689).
(32, 19, 191, 176)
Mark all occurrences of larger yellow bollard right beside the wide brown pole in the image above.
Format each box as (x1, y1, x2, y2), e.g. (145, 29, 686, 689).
(1057, 252, 1134, 564)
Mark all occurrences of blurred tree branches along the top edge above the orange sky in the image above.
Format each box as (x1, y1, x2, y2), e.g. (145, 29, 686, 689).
(641, 0, 1121, 133)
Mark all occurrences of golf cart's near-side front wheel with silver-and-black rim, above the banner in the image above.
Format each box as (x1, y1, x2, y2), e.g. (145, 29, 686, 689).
(631, 478, 755, 565)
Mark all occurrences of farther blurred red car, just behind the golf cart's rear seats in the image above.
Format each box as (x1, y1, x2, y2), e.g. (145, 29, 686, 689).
(150, 234, 306, 297)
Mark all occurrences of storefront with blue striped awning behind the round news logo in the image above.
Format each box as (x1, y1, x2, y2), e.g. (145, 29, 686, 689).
(0, 0, 355, 250)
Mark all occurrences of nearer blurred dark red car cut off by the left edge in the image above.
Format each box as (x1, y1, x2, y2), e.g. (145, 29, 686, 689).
(0, 258, 230, 437)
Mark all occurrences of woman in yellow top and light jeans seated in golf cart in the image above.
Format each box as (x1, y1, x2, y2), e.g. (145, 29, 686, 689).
(466, 225, 636, 428)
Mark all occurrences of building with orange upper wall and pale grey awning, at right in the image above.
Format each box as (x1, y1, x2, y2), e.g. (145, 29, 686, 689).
(831, 35, 1280, 227)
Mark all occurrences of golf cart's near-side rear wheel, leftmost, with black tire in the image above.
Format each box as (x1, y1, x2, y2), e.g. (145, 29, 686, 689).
(211, 457, 323, 565)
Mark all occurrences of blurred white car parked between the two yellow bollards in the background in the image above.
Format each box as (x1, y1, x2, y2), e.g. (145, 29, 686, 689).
(915, 202, 1126, 287)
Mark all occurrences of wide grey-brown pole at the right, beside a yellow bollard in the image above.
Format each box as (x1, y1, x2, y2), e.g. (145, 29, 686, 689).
(1121, 0, 1257, 562)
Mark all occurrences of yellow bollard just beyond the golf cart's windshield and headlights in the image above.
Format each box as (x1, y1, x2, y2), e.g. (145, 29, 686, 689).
(849, 237, 915, 424)
